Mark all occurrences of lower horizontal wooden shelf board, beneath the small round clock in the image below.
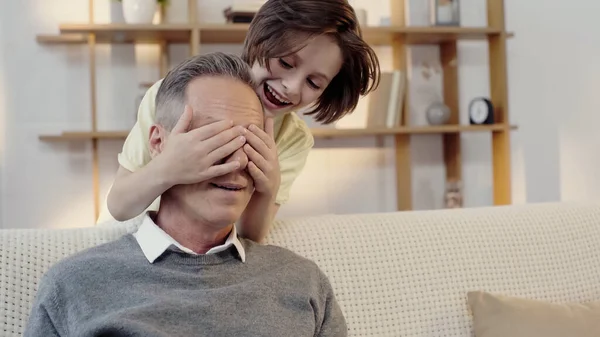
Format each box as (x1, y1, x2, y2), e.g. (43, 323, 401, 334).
(39, 124, 517, 141)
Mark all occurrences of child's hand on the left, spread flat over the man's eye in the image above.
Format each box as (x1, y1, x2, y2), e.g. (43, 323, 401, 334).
(156, 105, 250, 186)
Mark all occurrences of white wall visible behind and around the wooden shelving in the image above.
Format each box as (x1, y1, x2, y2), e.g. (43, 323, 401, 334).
(0, 0, 600, 227)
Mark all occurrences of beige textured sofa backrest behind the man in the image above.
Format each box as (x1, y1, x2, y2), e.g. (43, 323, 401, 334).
(0, 203, 600, 337)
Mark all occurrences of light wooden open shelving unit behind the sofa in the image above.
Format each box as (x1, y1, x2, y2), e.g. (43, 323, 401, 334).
(37, 0, 516, 216)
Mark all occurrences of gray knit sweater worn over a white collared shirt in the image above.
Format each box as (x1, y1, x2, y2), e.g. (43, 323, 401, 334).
(24, 234, 347, 337)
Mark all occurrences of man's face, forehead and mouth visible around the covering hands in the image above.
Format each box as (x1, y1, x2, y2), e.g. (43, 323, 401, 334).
(152, 77, 264, 228)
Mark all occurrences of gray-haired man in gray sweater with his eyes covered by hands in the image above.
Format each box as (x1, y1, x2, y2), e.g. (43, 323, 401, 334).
(25, 53, 347, 337)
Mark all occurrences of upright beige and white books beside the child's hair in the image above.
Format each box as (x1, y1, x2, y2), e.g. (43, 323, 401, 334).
(366, 70, 406, 128)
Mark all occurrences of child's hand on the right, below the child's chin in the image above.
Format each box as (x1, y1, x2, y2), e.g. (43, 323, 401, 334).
(244, 117, 281, 197)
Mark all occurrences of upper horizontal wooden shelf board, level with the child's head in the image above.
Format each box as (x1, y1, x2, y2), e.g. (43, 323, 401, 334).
(37, 24, 512, 45)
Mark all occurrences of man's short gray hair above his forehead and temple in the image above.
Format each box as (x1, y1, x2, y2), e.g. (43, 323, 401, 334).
(155, 52, 255, 130)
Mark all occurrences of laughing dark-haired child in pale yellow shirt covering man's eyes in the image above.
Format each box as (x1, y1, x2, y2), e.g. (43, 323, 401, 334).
(99, 0, 380, 242)
